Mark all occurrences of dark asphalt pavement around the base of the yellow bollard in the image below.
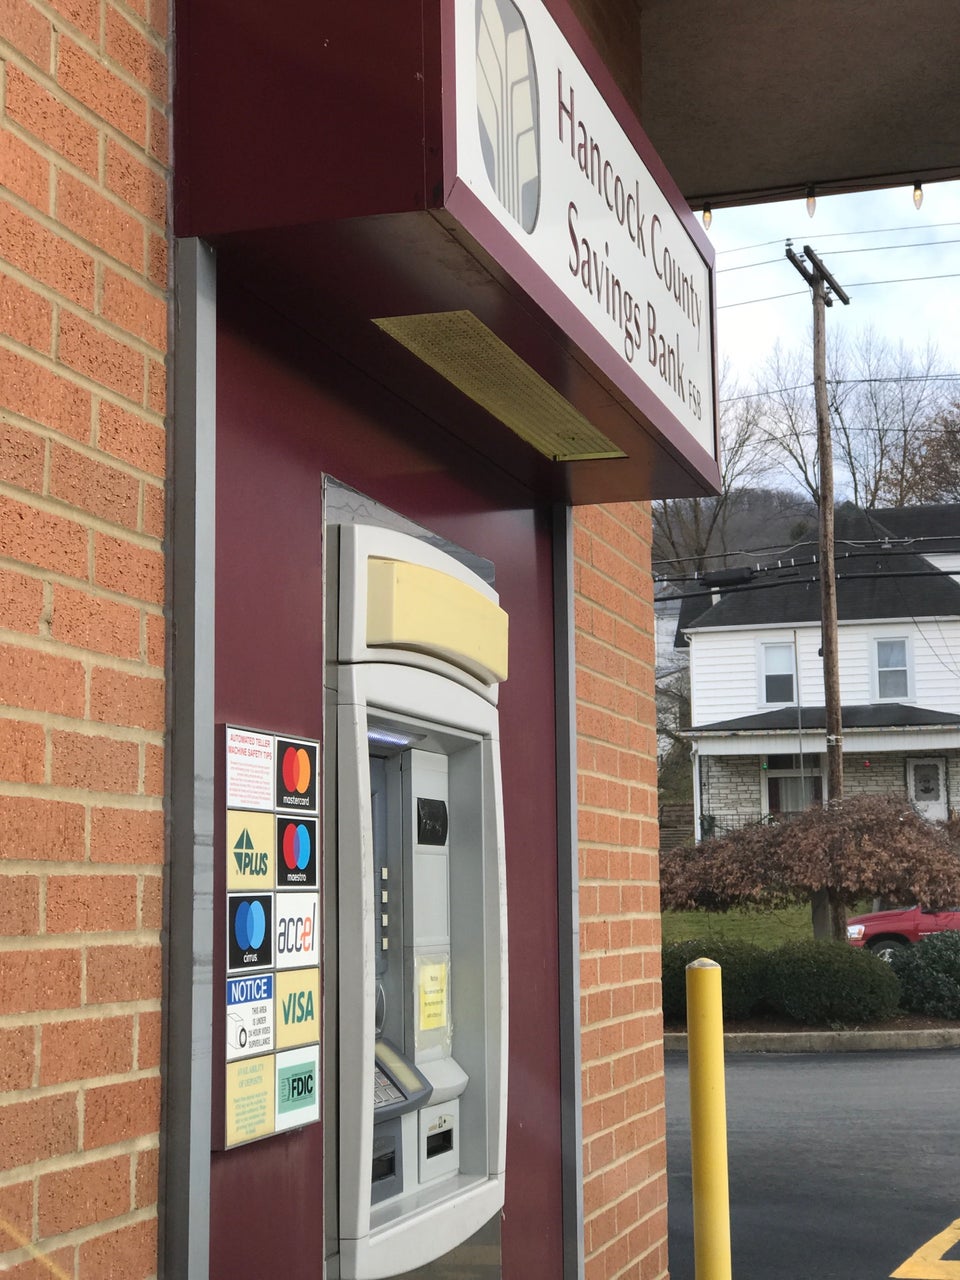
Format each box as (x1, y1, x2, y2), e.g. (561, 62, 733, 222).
(667, 1050, 960, 1280)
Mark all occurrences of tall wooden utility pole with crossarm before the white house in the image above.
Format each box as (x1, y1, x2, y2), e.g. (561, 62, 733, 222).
(786, 242, 850, 937)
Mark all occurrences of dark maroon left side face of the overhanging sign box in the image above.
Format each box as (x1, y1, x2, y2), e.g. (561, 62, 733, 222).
(173, 0, 440, 236)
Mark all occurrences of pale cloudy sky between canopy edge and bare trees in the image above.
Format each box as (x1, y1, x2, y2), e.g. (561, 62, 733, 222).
(708, 182, 960, 383)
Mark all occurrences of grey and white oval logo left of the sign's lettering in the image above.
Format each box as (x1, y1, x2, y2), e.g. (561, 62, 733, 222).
(476, 0, 540, 232)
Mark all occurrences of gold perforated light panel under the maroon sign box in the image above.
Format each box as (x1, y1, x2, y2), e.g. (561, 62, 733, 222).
(374, 311, 626, 462)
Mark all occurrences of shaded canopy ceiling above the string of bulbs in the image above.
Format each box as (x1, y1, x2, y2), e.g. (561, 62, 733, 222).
(572, 0, 960, 209)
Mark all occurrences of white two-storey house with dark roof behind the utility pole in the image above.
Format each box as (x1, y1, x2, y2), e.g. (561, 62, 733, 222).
(677, 504, 960, 835)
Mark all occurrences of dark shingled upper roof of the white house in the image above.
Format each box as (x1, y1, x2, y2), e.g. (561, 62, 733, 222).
(677, 503, 960, 644)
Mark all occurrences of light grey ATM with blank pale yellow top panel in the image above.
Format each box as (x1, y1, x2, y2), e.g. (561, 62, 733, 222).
(325, 525, 507, 1280)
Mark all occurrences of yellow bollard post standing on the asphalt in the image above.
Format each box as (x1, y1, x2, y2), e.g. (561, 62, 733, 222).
(686, 959, 731, 1280)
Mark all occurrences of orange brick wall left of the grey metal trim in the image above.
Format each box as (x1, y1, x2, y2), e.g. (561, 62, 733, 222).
(0, 0, 168, 1280)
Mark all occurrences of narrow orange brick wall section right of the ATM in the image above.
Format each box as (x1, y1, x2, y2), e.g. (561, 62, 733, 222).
(573, 503, 667, 1280)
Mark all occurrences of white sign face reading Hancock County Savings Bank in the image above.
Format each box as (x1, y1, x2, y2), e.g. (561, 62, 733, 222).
(456, 0, 716, 457)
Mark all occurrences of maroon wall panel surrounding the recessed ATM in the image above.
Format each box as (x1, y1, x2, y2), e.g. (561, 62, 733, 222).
(211, 280, 562, 1280)
